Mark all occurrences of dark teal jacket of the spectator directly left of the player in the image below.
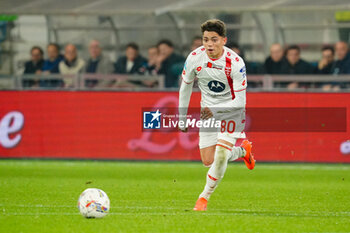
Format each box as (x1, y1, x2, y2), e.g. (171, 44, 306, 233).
(158, 53, 185, 87)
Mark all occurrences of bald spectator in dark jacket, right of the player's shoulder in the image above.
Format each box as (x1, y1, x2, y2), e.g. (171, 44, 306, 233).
(264, 43, 286, 74)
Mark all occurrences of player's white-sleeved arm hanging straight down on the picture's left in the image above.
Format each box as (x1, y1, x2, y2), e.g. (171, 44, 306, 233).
(179, 54, 196, 132)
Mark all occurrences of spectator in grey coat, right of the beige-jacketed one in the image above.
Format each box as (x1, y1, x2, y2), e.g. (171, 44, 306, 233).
(85, 40, 114, 87)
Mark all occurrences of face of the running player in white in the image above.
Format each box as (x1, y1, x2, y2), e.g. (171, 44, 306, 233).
(203, 31, 227, 59)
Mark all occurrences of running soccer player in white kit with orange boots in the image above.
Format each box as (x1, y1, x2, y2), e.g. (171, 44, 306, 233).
(179, 19, 255, 211)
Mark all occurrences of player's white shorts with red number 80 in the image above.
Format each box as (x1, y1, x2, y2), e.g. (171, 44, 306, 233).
(199, 110, 246, 149)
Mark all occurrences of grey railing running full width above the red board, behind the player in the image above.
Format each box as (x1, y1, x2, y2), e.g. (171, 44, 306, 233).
(0, 74, 350, 92)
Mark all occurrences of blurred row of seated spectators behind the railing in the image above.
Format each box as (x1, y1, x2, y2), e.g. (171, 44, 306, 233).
(24, 36, 350, 90)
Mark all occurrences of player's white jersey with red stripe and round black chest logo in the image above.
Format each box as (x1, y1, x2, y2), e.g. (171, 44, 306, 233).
(182, 46, 247, 107)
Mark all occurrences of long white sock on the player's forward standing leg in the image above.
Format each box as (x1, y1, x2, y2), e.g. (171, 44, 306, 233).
(199, 145, 231, 200)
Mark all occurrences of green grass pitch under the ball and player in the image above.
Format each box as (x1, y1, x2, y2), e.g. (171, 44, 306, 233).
(0, 160, 350, 233)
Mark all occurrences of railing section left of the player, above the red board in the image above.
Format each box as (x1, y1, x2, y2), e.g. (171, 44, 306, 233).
(0, 74, 164, 90)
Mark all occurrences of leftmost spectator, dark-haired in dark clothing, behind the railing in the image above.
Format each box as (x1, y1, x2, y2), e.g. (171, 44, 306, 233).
(23, 46, 44, 87)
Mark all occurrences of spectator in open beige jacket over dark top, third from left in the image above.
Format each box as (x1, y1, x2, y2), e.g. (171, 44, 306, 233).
(58, 44, 85, 87)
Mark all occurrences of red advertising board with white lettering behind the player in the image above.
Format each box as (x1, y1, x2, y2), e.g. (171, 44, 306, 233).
(0, 91, 350, 163)
